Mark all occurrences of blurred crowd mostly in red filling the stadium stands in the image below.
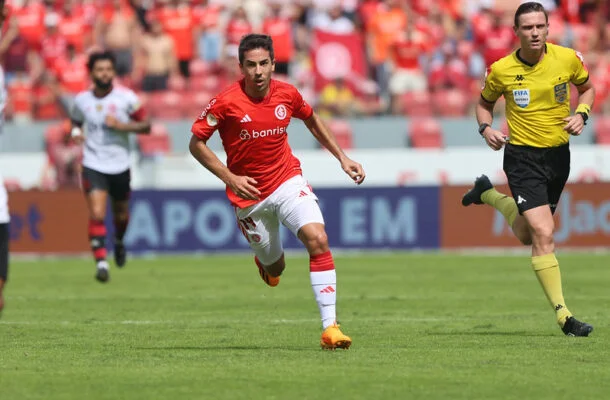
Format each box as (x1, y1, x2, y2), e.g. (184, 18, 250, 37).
(0, 0, 610, 122)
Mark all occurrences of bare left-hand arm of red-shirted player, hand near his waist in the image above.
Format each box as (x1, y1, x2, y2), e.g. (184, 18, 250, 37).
(189, 134, 261, 200)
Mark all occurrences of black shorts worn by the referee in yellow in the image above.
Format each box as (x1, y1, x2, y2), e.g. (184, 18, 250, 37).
(504, 143, 570, 214)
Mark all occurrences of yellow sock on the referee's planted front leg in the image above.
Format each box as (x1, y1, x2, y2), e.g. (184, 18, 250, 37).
(532, 253, 572, 326)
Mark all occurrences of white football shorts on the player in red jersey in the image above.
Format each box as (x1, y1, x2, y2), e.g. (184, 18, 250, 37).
(235, 175, 324, 265)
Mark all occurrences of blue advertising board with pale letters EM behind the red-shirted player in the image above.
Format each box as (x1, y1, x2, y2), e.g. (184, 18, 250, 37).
(113, 187, 440, 253)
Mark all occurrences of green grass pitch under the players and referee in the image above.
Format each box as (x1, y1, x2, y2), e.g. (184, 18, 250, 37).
(0, 253, 610, 400)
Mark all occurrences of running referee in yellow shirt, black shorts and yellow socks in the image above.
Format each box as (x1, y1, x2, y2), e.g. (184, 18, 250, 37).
(462, 2, 595, 336)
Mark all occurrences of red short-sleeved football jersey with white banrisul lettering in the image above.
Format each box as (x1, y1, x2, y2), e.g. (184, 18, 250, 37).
(192, 79, 313, 208)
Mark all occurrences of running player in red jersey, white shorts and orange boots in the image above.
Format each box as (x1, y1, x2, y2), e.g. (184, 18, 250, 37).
(189, 34, 365, 349)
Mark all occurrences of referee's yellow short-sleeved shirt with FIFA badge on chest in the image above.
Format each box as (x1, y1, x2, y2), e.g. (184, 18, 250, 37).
(481, 43, 589, 147)
